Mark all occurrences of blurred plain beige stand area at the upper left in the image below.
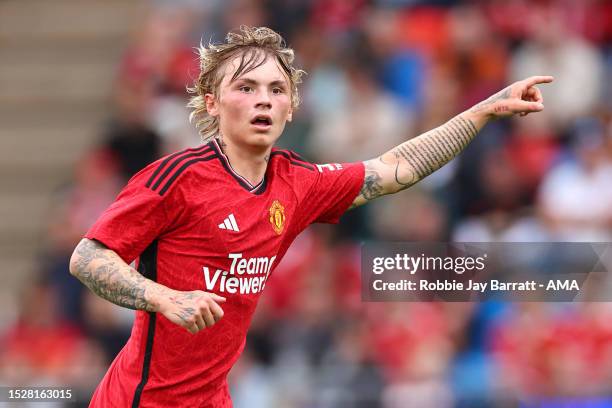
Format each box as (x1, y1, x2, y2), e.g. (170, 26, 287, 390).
(0, 0, 146, 321)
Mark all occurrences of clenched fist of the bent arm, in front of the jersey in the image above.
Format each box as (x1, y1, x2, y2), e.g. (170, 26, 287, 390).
(159, 290, 225, 334)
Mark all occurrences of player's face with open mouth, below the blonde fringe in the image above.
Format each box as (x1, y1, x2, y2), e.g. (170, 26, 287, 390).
(206, 56, 292, 148)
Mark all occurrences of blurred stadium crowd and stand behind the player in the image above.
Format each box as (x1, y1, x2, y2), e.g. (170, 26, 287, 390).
(0, 0, 612, 408)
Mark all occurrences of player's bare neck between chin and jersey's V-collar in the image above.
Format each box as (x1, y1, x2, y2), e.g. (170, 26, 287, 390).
(217, 138, 272, 186)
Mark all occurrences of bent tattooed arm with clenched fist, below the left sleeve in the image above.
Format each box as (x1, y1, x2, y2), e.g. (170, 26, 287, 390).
(70, 238, 225, 333)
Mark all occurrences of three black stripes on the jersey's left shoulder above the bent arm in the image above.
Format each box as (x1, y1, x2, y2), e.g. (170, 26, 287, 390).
(146, 144, 217, 195)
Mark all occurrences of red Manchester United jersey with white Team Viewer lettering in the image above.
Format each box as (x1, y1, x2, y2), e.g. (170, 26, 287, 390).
(86, 140, 364, 407)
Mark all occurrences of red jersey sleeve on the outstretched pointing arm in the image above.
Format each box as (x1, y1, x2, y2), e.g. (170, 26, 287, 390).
(300, 162, 365, 228)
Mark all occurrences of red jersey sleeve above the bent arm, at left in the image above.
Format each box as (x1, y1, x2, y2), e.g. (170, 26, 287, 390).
(85, 169, 182, 263)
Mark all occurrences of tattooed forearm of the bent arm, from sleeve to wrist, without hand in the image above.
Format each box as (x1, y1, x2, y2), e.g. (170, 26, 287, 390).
(72, 239, 159, 312)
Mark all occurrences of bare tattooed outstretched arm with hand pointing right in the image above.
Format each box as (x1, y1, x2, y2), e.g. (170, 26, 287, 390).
(351, 76, 553, 208)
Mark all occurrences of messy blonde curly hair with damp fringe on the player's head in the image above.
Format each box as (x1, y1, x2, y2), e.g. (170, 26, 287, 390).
(187, 26, 305, 141)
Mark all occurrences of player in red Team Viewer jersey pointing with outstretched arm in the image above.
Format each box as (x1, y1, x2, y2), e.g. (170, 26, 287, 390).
(70, 27, 552, 407)
